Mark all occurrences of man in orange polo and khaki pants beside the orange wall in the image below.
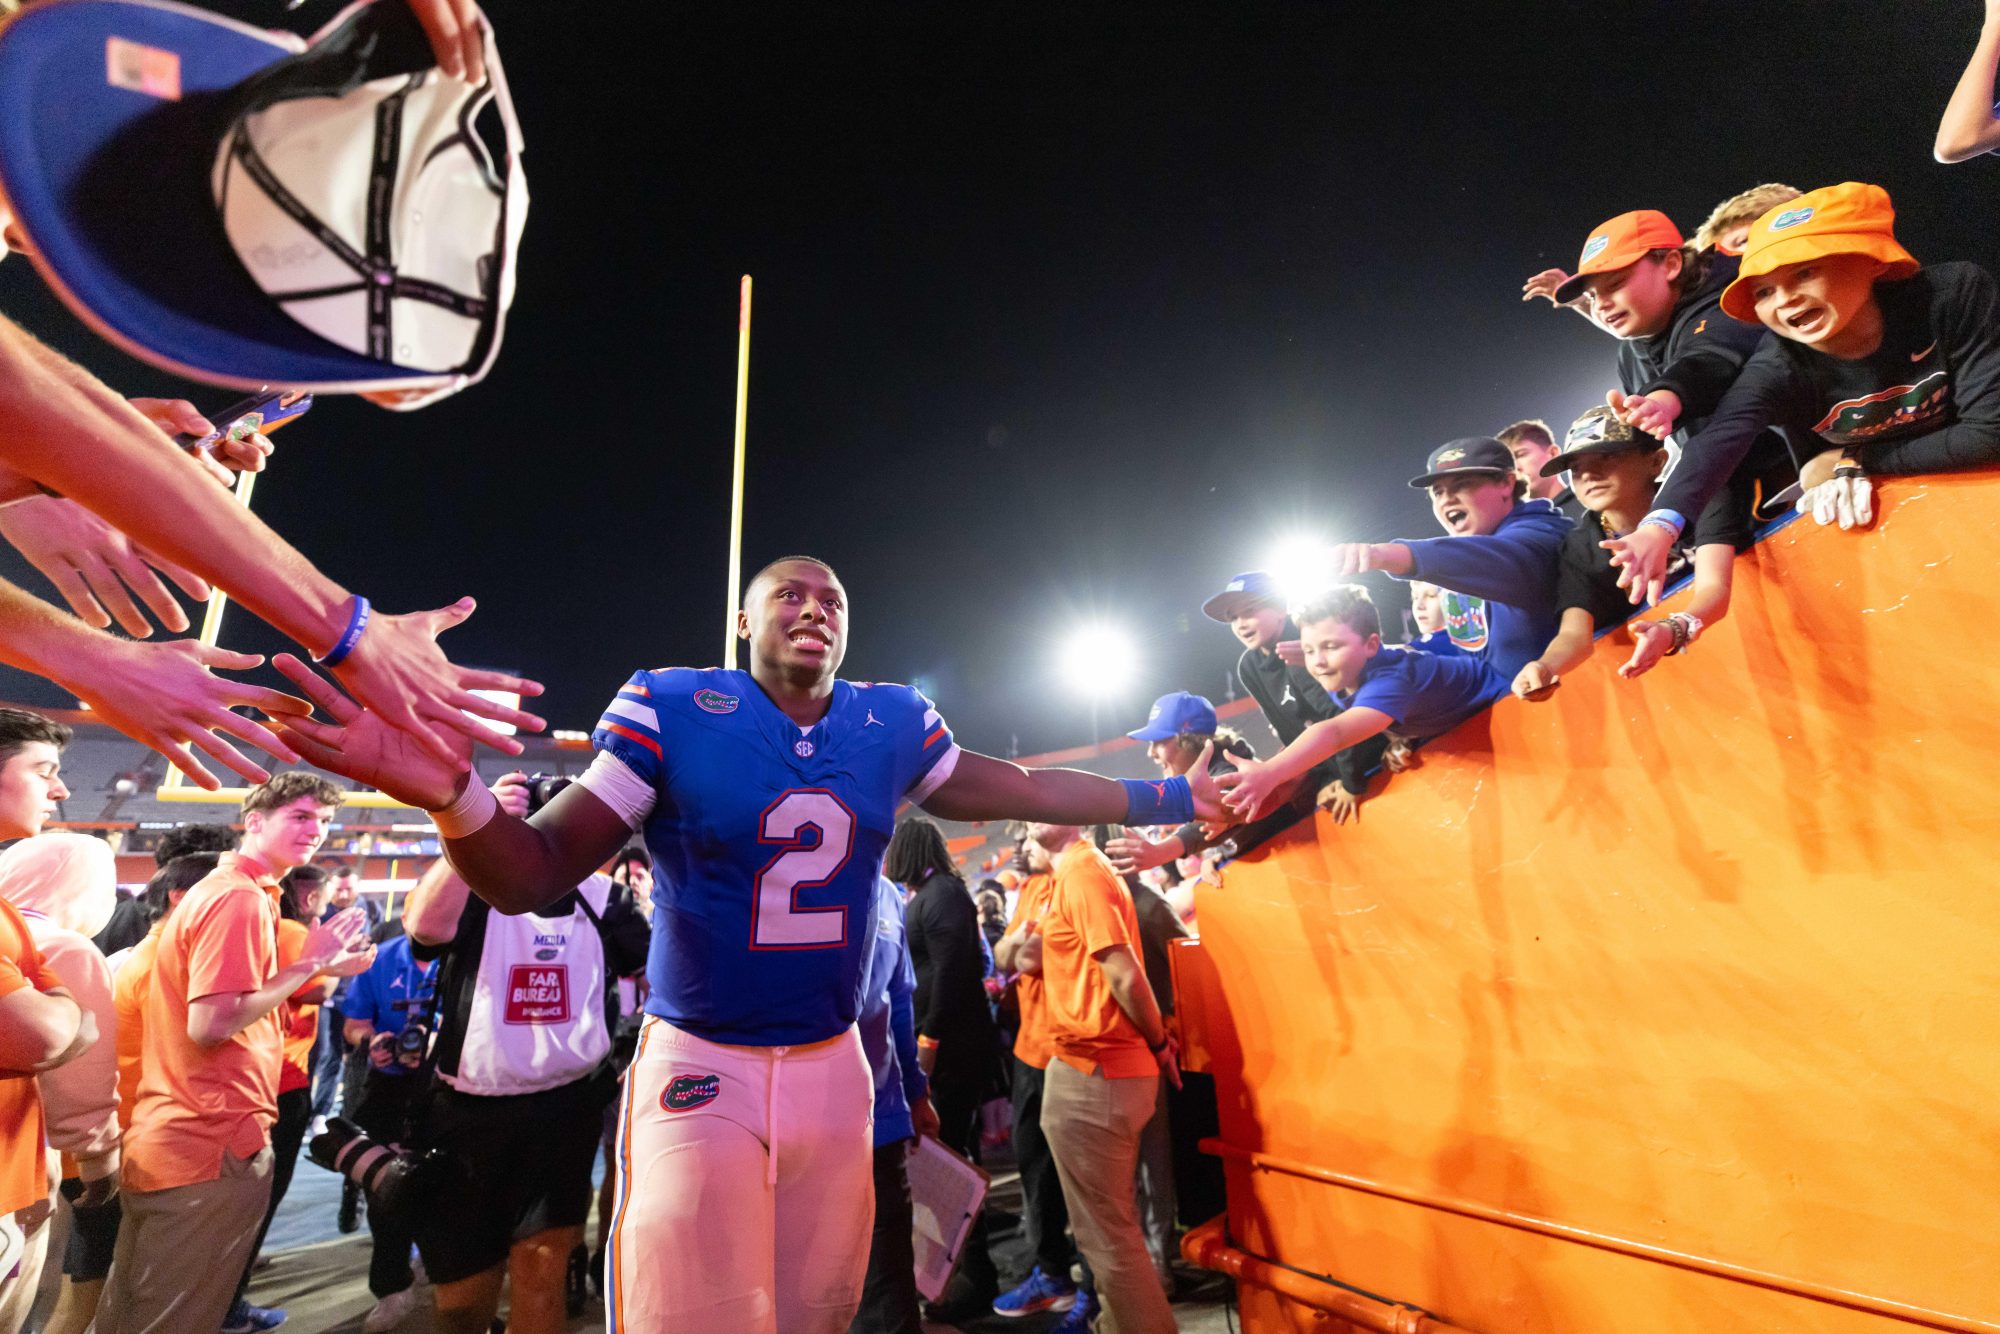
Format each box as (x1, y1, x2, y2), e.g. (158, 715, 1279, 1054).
(1028, 824, 1180, 1334)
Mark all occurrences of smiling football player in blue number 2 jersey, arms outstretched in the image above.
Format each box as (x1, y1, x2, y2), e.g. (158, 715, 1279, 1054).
(262, 556, 1232, 1334)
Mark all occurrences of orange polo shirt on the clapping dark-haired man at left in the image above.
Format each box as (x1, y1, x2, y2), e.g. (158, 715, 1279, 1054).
(124, 852, 284, 1190)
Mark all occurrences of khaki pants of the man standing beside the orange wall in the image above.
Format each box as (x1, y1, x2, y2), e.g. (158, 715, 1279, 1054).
(1042, 1060, 1180, 1334)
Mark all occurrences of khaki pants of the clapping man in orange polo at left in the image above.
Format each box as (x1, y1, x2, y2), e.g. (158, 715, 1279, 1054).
(92, 1148, 272, 1334)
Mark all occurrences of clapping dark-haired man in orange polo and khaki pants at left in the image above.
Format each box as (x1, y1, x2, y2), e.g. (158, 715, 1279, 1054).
(96, 772, 374, 1334)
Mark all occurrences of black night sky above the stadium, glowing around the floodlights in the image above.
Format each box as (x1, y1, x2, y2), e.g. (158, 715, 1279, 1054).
(0, 0, 2000, 754)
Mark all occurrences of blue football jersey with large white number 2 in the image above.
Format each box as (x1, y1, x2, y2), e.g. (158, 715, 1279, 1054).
(590, 668, 958, 1046)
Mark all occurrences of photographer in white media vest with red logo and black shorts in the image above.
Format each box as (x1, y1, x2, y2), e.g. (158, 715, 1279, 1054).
(390, 774, 648, 1334)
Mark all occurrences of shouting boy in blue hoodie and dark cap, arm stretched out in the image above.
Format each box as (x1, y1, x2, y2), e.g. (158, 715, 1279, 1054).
(1334, 436, 1570, 698)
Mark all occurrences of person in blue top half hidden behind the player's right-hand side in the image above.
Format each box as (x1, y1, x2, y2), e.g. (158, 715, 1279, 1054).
(848, 876, 938, 1334)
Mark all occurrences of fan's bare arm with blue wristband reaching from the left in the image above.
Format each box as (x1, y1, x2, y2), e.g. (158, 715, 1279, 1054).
(0, 318, 542, 756)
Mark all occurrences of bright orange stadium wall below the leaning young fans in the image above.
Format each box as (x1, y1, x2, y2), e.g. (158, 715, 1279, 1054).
(1174, 478, 2000, 1334)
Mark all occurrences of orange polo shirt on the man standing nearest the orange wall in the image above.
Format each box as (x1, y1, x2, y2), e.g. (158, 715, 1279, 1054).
(1042, 838, 1160, 1080)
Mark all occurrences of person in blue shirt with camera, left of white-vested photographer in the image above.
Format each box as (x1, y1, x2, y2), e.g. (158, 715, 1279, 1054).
(342, 936, 436, 1334)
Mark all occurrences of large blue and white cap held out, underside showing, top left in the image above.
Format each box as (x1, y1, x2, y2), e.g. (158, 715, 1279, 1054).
(0, 0, 526, 406)
